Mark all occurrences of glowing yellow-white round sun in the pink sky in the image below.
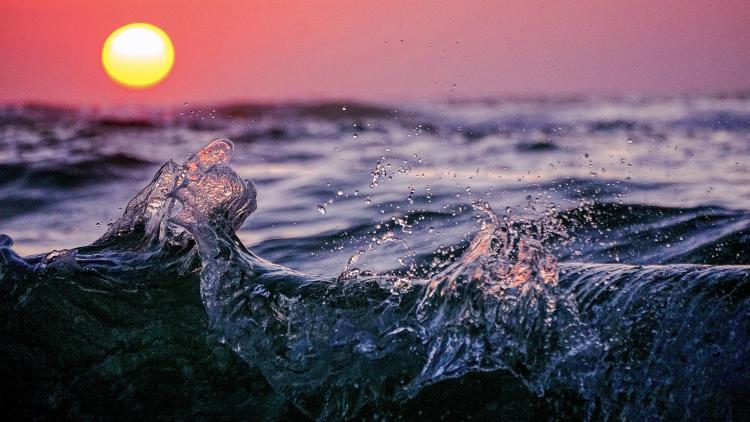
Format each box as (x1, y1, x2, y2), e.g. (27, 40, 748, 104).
(102, 23, 174, 88)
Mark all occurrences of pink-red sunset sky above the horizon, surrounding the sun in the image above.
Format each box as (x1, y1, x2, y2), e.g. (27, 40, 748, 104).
(0, 0, 750, 105)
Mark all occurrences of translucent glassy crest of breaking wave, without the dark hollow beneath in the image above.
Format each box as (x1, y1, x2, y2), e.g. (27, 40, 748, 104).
(0, 140, 750, 419)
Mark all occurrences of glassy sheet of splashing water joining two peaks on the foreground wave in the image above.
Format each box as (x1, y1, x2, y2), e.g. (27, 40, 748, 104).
(142, 141, 596, 419)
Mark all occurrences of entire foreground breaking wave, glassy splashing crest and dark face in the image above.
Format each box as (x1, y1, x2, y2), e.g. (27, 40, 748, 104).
(0, 136, 750, 420)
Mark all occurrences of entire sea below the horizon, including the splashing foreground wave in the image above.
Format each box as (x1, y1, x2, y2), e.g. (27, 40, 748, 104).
(0, 96, 750, 420)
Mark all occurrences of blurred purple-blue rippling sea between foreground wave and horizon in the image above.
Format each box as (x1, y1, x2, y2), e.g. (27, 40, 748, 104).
(0, 94, 750, 268)
